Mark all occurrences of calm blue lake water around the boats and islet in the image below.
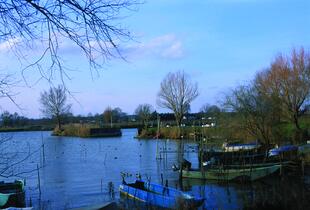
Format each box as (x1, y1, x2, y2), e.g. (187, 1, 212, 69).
(1, 129, 310, 210)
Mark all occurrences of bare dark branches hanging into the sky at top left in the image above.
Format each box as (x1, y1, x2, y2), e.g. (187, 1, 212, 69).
(0, 0, 141, 80)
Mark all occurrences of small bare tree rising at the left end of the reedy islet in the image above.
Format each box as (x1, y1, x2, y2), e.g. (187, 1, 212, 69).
(40, 85, 71, 130)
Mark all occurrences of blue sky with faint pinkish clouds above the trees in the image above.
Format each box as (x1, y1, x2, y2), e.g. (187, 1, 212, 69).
(0, 0, 310, 117)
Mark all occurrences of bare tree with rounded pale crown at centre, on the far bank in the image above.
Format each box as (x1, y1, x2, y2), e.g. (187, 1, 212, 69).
(157, 71, 198, 127)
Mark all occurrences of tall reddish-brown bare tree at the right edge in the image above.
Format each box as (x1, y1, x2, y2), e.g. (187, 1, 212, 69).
(259, 48, 310, 130)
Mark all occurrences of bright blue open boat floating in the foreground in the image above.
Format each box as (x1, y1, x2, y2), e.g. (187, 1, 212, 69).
(119, 180, 204, 209)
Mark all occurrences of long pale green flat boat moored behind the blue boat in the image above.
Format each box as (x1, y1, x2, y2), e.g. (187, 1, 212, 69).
(182, 164, 282, 181)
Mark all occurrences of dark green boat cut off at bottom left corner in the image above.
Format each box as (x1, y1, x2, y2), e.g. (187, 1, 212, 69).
(0, 180, 25, 208)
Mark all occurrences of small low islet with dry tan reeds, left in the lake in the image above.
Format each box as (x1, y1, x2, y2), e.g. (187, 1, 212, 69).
(52, 124, 122, 138)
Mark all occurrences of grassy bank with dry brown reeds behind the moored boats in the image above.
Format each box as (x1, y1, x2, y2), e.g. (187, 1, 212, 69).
(137, 120, 310, 145)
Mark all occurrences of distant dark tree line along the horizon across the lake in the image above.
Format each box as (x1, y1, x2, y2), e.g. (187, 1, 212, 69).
(0, 107, 223, 128)
